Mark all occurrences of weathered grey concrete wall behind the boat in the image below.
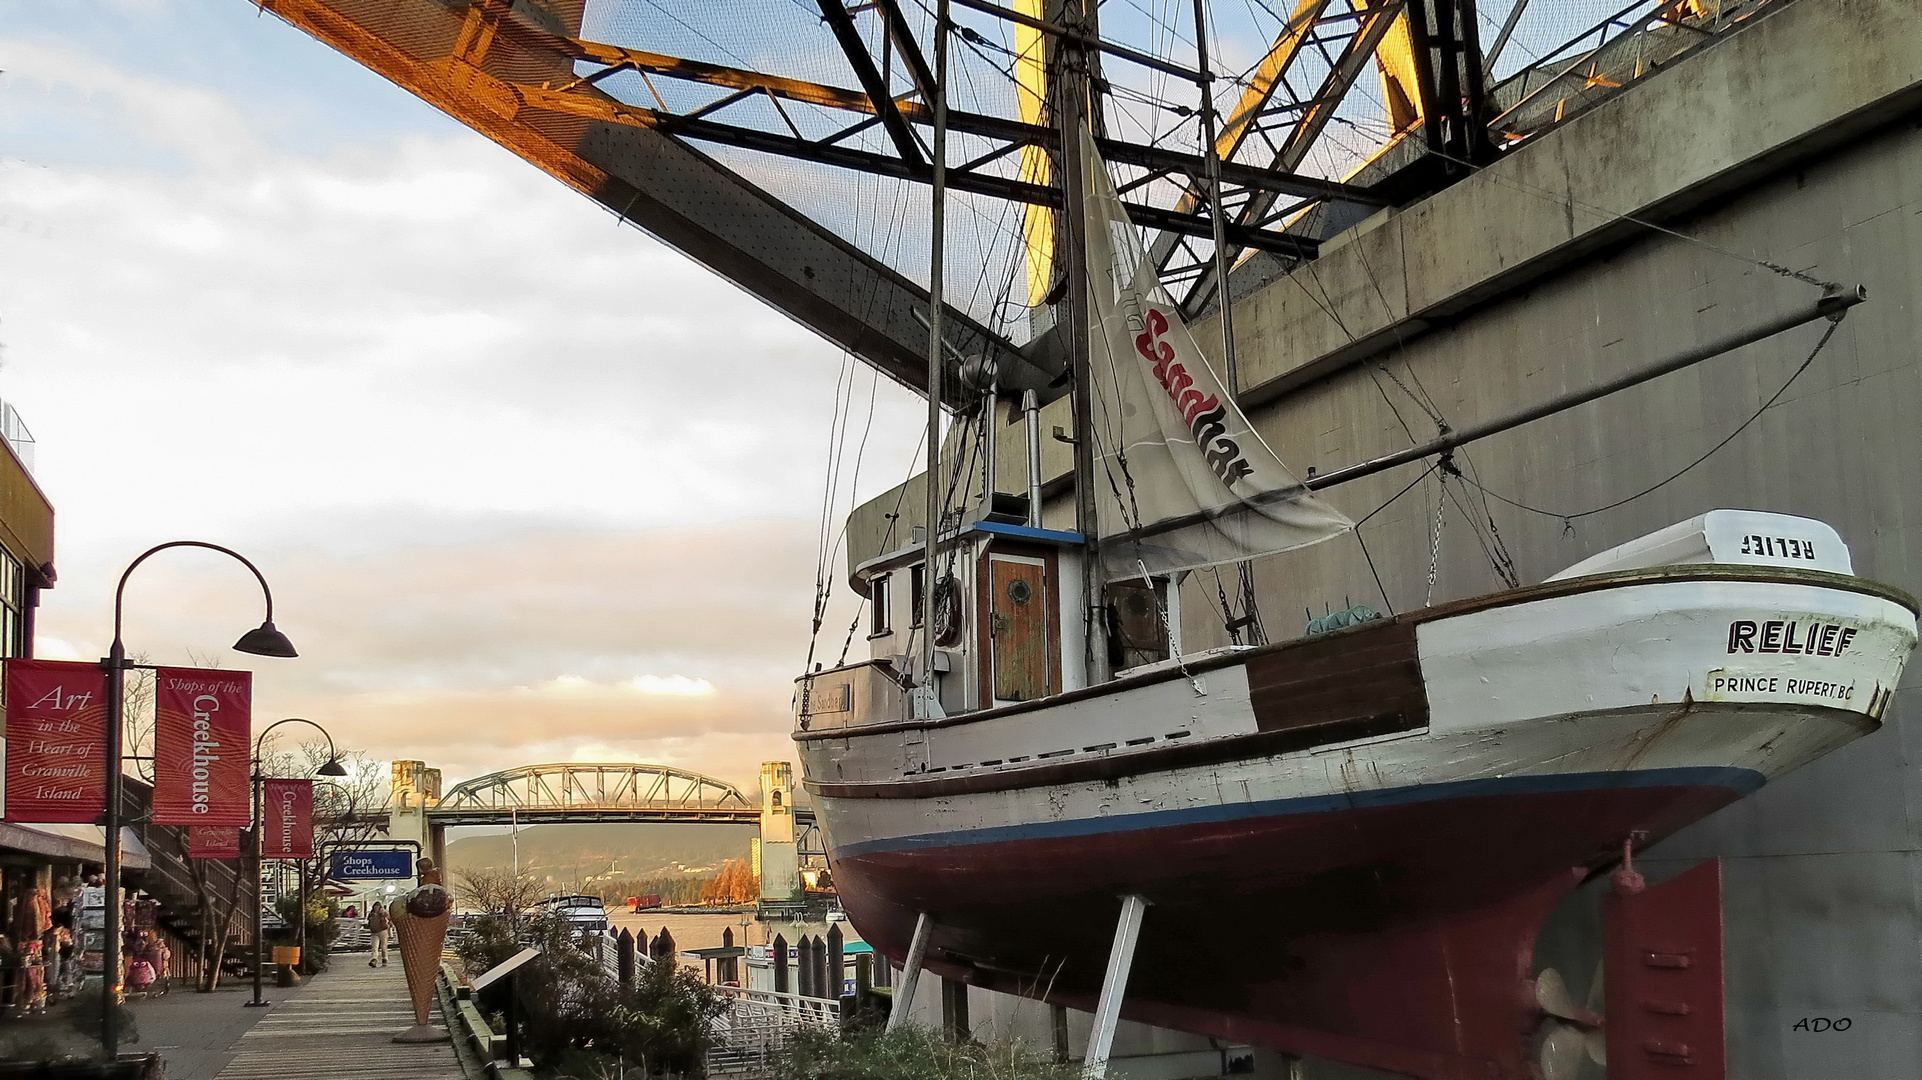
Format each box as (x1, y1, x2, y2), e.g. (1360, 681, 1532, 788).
(1184, 0, 1922, 1080)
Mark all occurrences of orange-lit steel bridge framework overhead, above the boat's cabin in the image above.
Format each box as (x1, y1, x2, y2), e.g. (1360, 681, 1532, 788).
(256, 0, 1789, 404)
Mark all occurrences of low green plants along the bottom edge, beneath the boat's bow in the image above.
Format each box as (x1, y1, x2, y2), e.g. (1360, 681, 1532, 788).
(775, 1024, 1080, 1080)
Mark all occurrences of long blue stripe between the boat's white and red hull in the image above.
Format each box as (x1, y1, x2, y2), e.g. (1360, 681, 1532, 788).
(834, 765, 1764, 857)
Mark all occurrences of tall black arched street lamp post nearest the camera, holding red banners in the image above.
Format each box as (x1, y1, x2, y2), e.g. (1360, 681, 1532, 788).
(100, 540, 300, 1061)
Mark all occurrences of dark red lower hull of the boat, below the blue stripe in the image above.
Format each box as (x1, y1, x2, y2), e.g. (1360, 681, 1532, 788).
(834, 769, 1761, 1080)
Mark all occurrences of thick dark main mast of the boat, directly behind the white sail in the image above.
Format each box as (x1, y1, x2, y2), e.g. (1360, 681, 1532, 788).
(1055, 0, 1109, 684)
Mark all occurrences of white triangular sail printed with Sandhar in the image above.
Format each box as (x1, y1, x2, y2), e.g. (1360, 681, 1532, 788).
(1082, 131, 1353, 580)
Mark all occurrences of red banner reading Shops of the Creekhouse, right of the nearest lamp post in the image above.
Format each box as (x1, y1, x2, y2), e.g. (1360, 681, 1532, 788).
(154, 667, 254, 826)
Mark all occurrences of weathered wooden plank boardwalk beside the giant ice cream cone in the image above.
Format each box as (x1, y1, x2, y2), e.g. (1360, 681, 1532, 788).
(217, 955, 461, 1080)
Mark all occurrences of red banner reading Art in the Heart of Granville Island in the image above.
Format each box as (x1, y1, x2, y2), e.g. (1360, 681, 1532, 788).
(6, 659, 108, 824)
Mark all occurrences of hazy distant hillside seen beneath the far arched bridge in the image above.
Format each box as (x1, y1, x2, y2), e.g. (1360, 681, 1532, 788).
(448, 822, 757, 886)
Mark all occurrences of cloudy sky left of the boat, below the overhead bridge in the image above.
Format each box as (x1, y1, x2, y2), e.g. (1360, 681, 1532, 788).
(0, 0, 924, 788)
